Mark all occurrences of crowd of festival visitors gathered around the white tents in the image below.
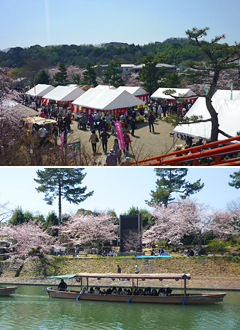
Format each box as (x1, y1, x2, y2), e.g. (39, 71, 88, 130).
(21, 91, 198, 166)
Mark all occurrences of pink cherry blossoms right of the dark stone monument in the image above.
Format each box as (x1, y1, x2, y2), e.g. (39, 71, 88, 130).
(143, 199, 235, 251)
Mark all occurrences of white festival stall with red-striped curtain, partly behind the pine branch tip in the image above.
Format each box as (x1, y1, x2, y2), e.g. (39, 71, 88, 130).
(151, 87, 197, 104)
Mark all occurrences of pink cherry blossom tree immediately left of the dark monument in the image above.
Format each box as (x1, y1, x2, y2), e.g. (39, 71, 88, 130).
(60, 212, 118, 248)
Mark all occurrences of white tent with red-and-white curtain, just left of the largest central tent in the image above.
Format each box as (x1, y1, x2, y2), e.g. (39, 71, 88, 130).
(42, 86, 85, 106)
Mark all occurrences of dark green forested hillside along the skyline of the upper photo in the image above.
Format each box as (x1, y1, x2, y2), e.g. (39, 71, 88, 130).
(0, 38, 203, 69)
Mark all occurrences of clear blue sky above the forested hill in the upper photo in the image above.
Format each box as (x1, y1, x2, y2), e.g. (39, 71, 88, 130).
(0, 0, 240, 49)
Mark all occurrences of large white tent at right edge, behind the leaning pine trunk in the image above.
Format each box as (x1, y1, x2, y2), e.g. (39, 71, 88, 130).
(173, 97, 240, 140)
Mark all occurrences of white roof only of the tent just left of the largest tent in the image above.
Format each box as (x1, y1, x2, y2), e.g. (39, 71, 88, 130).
(44, 86, 85, 102)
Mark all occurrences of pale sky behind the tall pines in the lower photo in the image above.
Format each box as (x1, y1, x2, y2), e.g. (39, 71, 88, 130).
(0, 167, 240, 216)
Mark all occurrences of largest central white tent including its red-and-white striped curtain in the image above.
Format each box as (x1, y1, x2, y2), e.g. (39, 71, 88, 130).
(72, 88, 142, 115)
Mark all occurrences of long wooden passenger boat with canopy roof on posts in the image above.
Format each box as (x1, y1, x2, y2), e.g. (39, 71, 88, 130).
(46, 273, 226, 305)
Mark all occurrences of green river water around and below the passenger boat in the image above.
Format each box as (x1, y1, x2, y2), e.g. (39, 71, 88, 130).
(0, 285, 240, 330)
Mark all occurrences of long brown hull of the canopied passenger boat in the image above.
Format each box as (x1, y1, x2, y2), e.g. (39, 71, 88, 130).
(47, 289, 226, 305)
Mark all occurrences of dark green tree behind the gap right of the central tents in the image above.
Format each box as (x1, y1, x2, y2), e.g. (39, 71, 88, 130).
(139, 54, 165, 95)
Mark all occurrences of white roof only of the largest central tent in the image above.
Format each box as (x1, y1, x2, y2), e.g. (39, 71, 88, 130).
(73, 88, 142, 110)
